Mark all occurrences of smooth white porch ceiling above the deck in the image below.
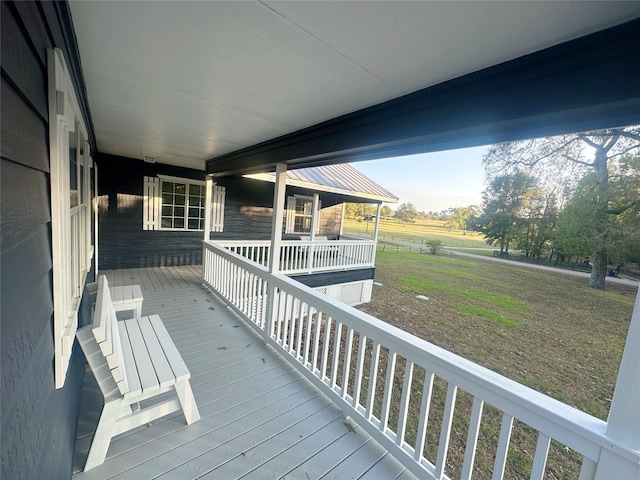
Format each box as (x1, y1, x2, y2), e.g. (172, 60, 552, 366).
(70, 1, 640, 170)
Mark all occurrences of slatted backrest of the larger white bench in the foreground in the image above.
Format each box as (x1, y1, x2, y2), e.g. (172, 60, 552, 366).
(92, 275, 129, 395)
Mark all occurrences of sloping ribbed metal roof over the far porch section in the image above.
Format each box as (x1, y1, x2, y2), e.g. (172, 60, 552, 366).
(244, 163, 398, 203)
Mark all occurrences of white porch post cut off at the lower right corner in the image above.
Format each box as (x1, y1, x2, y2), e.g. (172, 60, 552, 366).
(595, 289, 640, 480)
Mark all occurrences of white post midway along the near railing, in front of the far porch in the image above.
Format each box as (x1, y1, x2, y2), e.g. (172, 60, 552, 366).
(264, 163, 287, 343)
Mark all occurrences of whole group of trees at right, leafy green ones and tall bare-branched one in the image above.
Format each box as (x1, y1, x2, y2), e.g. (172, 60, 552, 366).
(467, 127, 640, 289)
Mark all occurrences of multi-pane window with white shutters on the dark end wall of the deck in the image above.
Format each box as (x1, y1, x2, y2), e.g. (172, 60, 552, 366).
(143, 175, 225, 232)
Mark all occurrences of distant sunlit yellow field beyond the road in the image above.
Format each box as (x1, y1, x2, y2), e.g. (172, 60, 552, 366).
(344, 218, 490, 248)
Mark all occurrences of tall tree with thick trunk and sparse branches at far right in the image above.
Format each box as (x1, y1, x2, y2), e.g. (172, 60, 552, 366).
(483, 126, 640, 289)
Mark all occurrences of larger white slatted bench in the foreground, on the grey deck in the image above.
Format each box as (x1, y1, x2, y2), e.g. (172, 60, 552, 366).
(76, 275, 200, 471)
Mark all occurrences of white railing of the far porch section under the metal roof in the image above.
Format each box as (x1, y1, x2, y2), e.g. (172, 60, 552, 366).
(215, 240, 376, 275)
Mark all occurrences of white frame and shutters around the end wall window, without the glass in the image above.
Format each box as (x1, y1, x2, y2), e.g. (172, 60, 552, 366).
(142, 174, 226, 232)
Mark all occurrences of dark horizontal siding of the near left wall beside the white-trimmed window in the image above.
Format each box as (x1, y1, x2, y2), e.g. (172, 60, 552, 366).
(0, 2, 93, 479)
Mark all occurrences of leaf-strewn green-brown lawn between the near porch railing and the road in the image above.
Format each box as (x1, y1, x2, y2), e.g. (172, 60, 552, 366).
(359, 249, 635, 479)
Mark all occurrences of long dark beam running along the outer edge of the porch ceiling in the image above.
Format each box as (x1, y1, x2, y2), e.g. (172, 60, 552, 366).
(206, 20, 640, 175)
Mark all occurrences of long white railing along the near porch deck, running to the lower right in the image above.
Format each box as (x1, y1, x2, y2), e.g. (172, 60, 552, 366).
(203, 242, 640, 480)
